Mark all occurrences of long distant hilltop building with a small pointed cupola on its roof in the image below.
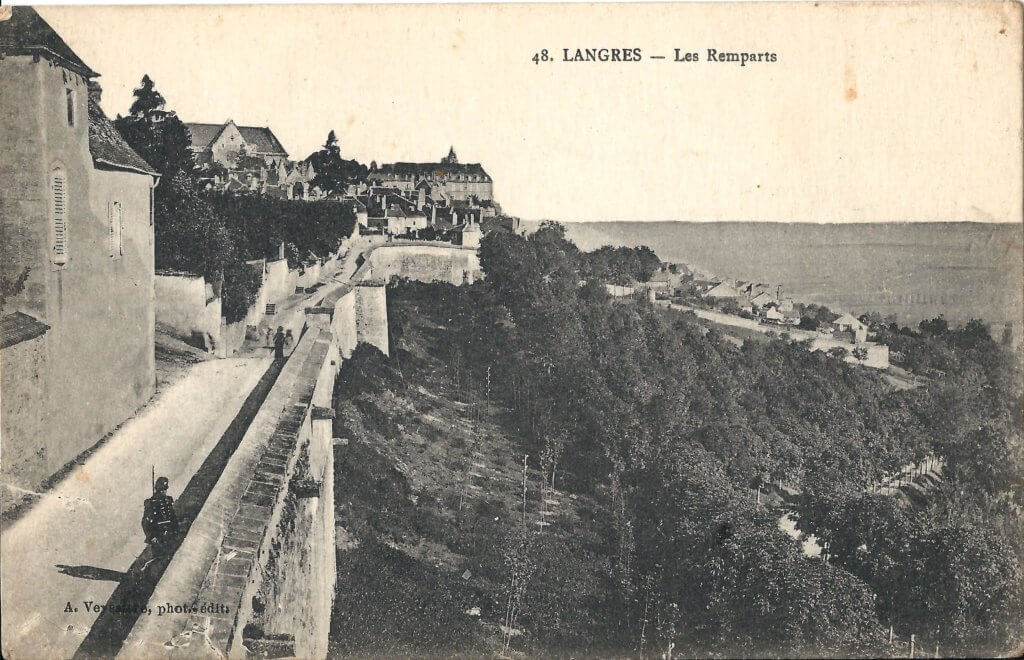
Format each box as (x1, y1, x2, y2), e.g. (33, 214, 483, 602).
(367, 147, 495, 202)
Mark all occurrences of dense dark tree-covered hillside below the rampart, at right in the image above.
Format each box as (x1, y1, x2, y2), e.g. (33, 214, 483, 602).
(331, 224, 1024, 657)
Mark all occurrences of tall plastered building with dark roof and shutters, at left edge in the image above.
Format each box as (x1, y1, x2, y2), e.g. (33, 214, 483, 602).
(0, 6, 159, 488)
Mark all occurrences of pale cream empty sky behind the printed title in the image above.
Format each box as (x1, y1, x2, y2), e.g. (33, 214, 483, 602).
(38, 3, 1024, 222)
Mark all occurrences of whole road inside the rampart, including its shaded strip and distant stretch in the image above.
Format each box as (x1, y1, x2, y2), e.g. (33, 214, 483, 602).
(0, 256, 354, 659)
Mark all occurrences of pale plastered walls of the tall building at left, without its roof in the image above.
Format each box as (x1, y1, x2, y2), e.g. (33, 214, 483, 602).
(0, 56, 156, 487)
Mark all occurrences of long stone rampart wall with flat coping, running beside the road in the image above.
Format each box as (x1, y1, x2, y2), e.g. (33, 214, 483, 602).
(121, 240, 476, 658)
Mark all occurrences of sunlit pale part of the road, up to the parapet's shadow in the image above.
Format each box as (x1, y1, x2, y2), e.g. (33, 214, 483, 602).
(0, 357, 270, 658)
